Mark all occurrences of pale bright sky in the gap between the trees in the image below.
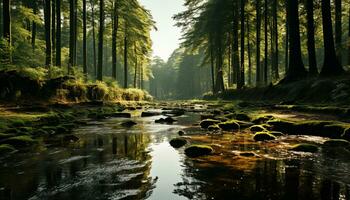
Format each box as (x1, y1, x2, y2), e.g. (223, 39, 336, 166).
(140, 0, 185, 61)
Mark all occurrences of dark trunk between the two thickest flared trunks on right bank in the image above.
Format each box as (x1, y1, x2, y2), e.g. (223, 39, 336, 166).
(305, 0, 318, 76)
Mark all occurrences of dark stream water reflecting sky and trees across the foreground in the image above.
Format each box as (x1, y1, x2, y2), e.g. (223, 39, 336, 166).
(0, 108, 350, 200)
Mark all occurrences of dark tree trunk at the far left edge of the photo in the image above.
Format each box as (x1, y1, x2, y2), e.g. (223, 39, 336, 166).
(2, 0, 12, 63)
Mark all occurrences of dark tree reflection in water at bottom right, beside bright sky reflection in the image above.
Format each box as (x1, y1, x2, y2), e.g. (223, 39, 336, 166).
(174, 159, 350, 200)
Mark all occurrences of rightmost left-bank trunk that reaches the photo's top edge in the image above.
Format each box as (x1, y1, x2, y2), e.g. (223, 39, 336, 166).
(112, 0, 119, 80)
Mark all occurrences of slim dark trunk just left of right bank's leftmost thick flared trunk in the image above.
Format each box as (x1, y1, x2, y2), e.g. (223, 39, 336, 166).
(271, 0, 279, 81)
